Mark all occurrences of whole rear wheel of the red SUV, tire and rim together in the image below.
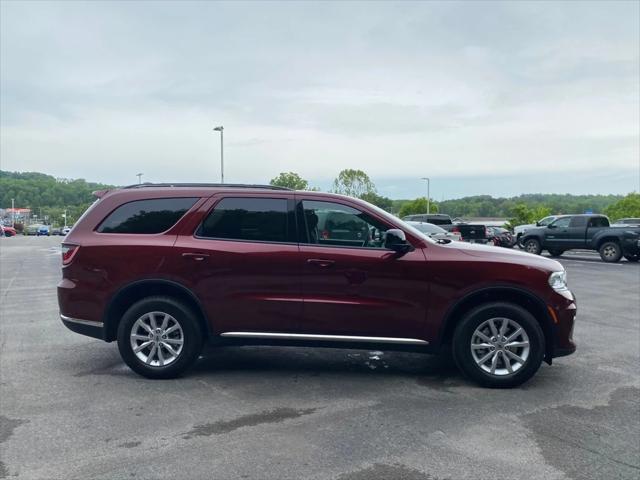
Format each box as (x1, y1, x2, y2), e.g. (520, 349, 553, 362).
(118, 297, 203, 378)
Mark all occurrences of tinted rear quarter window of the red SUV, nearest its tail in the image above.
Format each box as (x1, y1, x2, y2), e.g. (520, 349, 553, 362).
(97, 197, 198, 234)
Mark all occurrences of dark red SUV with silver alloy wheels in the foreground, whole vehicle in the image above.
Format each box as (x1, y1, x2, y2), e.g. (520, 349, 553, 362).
(58, 184, 576, 386)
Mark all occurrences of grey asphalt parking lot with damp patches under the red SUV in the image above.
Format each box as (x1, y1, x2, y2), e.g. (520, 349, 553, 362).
(0, 237, 640, 480)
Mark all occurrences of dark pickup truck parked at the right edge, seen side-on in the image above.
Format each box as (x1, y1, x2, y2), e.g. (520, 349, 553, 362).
(522, 215, 640, 262)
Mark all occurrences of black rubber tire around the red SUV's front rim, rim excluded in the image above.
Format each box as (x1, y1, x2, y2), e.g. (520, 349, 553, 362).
(452, 302, 545, 388)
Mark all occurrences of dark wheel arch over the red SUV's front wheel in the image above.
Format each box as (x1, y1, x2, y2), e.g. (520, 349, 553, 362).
(438, 285, 555, 363)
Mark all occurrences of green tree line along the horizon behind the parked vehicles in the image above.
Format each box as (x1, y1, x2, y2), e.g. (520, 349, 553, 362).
(0, 169, 640, 225)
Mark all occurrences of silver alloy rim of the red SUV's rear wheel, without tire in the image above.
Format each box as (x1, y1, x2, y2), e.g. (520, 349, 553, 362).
(131, 312, 184, 367)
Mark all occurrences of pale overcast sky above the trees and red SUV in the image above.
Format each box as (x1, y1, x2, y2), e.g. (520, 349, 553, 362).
(0, 1, 640, 200)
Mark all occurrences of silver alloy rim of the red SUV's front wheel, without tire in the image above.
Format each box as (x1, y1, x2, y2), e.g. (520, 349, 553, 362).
(471, 317, 530, 376)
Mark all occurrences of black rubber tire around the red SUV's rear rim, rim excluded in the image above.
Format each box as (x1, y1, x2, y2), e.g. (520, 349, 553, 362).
(118, 296, 204, 379)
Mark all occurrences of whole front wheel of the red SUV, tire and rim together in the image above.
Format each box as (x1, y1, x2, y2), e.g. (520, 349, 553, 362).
(453, 302, 545, 388)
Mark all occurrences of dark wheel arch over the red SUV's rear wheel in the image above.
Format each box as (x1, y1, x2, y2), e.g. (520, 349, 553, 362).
(103, 279, 211, 342)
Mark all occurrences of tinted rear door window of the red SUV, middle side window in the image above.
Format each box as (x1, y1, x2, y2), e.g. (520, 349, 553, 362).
(196, 197, 295, 243)
